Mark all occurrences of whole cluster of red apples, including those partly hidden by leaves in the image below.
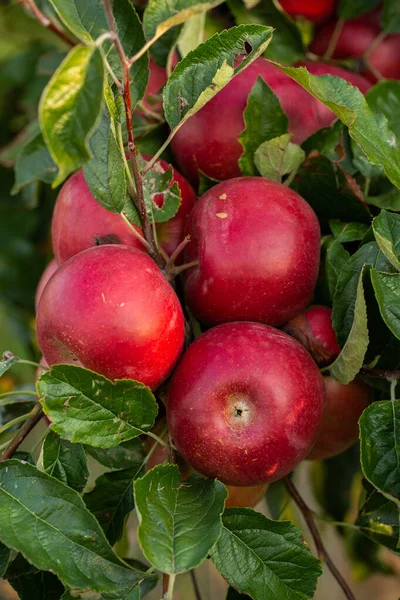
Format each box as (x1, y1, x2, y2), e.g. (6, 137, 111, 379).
(36, 0, 376, 505)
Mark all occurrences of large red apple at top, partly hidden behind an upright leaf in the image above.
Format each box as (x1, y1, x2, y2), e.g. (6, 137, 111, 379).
(171, 58, 365, 185)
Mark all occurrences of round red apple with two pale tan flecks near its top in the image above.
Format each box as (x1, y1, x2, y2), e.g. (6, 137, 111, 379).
(184, 177, 320, 325)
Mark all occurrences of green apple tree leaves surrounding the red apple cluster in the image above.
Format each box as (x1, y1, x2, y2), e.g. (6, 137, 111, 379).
(0, 0, 400, 600)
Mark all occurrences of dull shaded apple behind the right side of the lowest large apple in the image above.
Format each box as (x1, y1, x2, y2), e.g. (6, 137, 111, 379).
(308, 376, 372, 460)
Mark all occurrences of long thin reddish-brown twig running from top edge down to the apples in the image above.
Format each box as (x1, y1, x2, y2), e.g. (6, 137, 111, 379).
(104, 0, 164, 268)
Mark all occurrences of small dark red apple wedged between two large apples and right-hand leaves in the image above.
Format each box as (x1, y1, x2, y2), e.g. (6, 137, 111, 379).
(284, 306, 340, 367)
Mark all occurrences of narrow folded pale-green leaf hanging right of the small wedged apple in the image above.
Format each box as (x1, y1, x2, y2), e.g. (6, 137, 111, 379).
(329, 268, 369, 384)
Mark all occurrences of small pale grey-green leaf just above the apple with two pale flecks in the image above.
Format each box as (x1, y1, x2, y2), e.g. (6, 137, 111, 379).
(254, 134, 306, 183)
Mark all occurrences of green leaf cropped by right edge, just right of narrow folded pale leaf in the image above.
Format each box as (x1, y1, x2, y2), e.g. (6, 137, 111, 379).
(371, 269, 400, 339)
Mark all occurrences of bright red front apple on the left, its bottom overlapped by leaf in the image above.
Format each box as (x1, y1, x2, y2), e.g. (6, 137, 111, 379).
(37, 245, 184, 389)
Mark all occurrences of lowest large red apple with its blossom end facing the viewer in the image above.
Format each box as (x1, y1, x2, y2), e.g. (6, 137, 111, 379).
(167, 322, 324, 486)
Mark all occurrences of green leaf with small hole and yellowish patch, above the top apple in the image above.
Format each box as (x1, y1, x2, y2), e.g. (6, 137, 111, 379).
(164, 25, 272, 130)
